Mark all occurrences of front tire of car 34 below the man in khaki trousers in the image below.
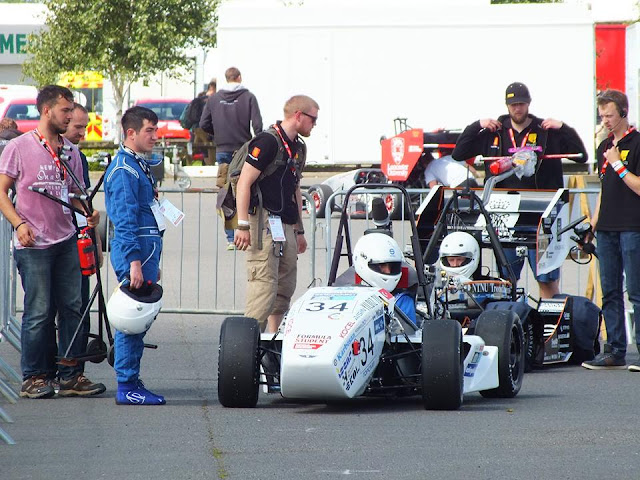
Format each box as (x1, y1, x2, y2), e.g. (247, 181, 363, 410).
(218, 317, 260, 408)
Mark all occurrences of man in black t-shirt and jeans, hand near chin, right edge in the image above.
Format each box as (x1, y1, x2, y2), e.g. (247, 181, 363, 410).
(582, 90, 640, 372)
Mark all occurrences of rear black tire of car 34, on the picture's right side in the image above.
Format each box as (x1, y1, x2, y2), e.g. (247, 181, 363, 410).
(475, 310, 525, 398)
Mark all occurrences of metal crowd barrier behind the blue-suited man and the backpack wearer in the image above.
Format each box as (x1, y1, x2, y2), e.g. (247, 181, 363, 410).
(6, 188, 318, 315)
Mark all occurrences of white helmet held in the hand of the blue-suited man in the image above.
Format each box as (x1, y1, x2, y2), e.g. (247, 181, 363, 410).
(107, 283, 162, 335)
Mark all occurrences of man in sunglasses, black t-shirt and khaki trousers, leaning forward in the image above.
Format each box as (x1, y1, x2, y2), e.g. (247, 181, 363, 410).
(235, 95, 319, 332)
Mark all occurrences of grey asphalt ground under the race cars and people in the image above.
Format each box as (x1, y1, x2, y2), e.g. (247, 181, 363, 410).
(0, 172, 640, 480)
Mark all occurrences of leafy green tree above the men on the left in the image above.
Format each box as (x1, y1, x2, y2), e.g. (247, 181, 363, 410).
(22, 0, 220, 138)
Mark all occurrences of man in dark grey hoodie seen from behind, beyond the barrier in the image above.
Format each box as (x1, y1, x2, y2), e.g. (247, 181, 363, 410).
(200, 67, 262, 250)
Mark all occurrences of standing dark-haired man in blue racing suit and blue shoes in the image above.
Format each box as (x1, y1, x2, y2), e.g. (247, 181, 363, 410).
(104, 107, 165, 405)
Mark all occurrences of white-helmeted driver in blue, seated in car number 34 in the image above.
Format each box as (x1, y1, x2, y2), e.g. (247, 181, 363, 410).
(353, 233, 416, 324)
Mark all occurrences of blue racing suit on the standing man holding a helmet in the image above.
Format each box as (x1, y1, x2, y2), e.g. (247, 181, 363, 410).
(104, 146, 162, 383)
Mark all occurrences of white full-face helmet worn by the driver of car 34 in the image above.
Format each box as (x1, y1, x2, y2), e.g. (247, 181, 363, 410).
(353, 233, 404, 292)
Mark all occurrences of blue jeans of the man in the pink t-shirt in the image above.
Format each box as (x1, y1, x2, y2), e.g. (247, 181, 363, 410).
(14, 235, 84, 380)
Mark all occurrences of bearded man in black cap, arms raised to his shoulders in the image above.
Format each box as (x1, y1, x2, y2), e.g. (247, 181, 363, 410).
(452, 82, 587, 298)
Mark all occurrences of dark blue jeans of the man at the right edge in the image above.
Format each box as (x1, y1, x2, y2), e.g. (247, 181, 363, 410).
(596, 231, 640, 357)
